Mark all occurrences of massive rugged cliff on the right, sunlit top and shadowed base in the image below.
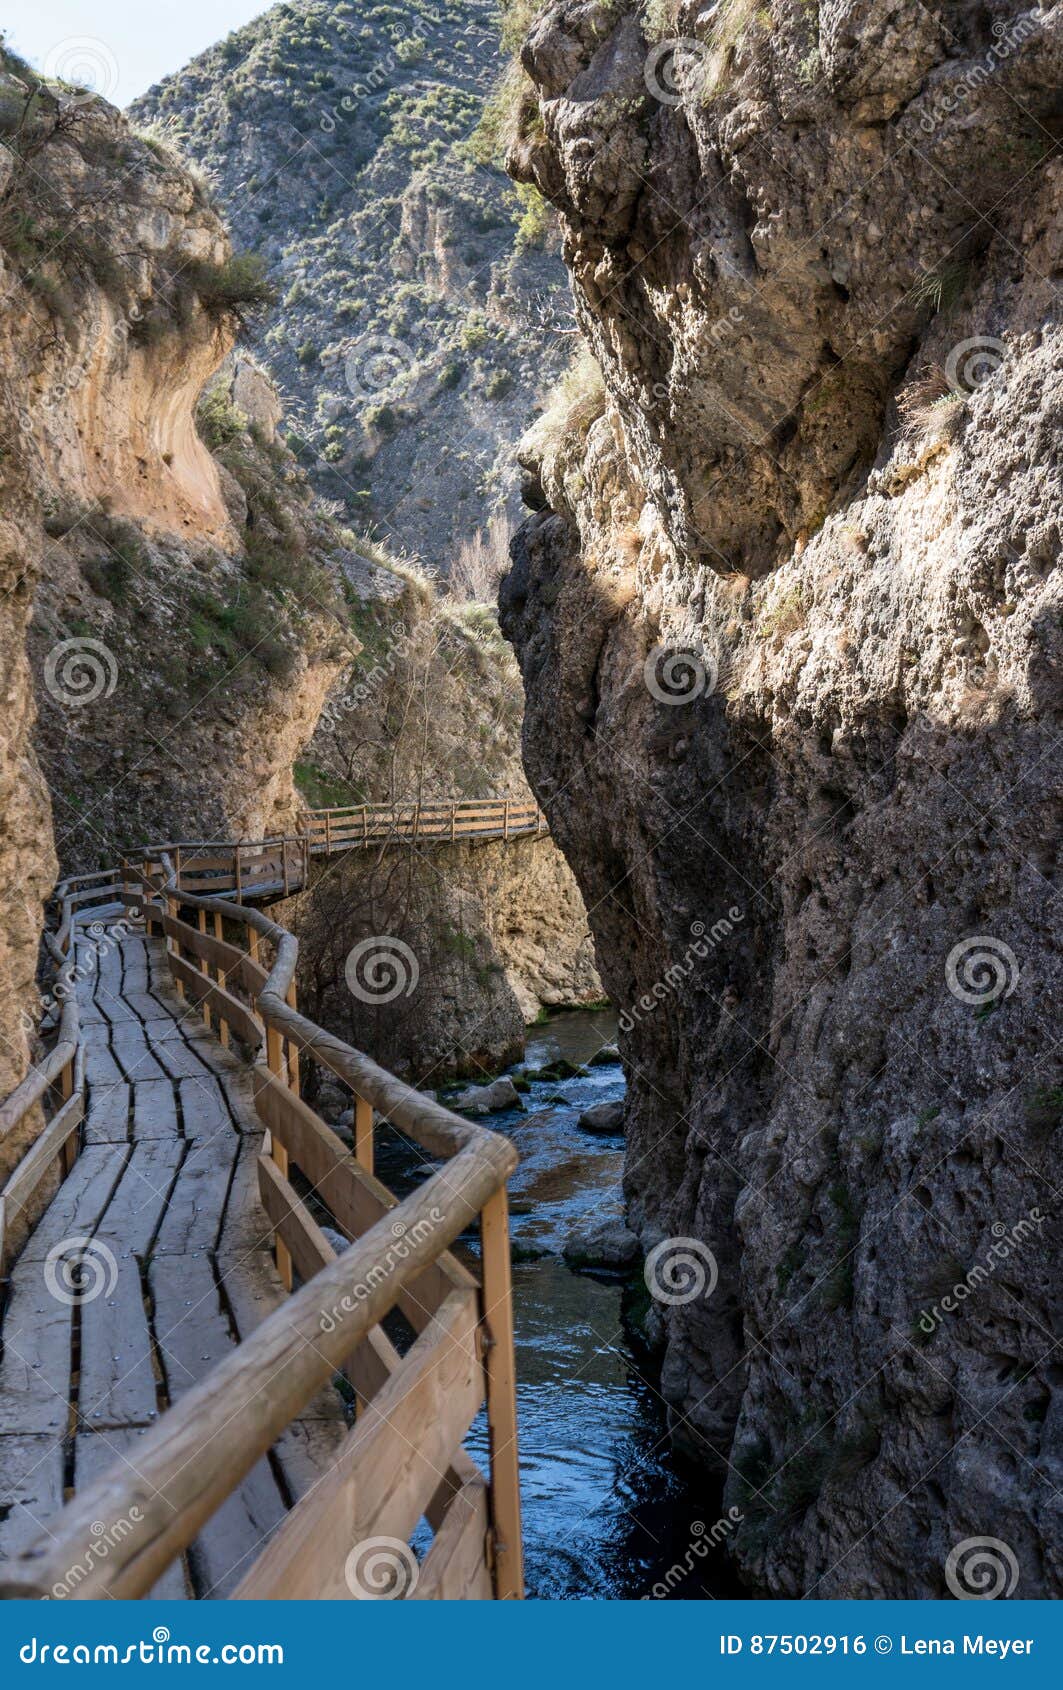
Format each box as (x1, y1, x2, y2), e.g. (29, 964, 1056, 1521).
(502, 0, 1063, 1597)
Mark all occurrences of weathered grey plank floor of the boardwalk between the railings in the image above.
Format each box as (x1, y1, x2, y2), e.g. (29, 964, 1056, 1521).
(0, 933, 346, 1597)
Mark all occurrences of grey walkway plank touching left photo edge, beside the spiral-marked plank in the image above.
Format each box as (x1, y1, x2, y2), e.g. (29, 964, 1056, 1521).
(0, 1259, 73, 1435)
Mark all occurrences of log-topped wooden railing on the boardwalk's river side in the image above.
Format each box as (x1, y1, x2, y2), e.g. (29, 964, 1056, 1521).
(3, 842, 524, 1599)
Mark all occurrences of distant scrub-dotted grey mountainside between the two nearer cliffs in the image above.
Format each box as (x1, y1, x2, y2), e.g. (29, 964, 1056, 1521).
(134, 0, 566, 575)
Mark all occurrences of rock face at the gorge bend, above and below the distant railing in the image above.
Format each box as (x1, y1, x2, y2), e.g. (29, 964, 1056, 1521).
(282, 551, 602, 1083)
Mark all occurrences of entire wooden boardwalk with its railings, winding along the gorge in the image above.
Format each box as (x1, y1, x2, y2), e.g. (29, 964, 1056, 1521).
(0, 799, 544, 1600)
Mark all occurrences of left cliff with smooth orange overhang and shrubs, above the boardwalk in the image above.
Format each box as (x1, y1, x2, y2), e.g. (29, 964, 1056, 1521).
(0, 61, 357, 891)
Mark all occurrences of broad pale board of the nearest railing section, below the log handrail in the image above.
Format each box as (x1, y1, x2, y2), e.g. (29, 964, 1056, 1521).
(235, 1291, 485, 1600)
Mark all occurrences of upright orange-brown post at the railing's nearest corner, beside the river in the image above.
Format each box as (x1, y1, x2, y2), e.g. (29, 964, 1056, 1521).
(480, 1186, 524, 1602)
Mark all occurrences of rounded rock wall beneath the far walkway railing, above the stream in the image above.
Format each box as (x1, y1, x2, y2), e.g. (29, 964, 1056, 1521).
(279, 838, 602, 1087)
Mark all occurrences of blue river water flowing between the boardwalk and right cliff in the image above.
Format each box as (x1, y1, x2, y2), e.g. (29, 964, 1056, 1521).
(379, 1011, 742, 1600)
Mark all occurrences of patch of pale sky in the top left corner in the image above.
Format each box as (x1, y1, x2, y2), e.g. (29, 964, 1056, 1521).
(0, 0, 272, 106)
